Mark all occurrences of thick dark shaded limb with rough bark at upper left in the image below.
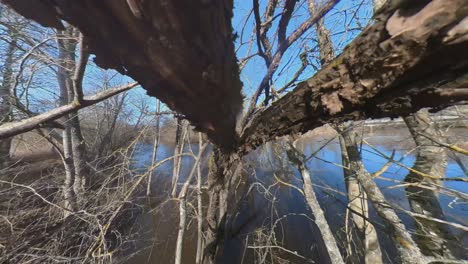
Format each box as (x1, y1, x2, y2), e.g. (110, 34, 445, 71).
(2, 0, 242, 147)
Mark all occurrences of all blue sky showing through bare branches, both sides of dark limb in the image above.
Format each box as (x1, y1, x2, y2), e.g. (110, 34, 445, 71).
(0, 0, 372, 119)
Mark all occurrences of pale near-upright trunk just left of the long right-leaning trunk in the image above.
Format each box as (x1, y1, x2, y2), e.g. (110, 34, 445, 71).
(338, 128, 382, 264)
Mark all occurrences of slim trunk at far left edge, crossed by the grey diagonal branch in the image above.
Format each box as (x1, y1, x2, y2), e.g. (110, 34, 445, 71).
(0, 28, 16, 170)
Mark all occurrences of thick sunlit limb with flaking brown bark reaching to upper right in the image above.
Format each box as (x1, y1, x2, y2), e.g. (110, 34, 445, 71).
(241, 0, 468, 153)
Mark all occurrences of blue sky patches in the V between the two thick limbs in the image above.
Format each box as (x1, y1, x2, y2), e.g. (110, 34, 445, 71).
(232, 0, 372, 101)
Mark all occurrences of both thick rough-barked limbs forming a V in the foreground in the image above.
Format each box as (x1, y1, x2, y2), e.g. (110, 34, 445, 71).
(2, 0, 468, 152)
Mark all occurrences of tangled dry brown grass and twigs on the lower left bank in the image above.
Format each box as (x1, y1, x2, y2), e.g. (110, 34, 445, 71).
(0, 152, 146, 263)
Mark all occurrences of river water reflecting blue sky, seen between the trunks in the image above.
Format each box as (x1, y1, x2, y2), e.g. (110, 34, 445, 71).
(126, 132, 468, 264)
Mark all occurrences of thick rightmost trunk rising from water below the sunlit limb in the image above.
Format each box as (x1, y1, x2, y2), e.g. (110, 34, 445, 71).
(404, 110, 460, 258)
